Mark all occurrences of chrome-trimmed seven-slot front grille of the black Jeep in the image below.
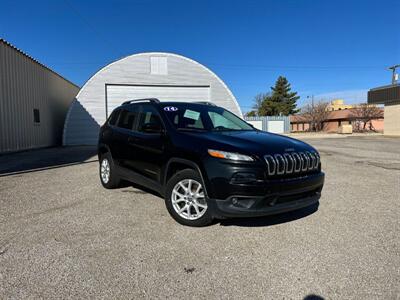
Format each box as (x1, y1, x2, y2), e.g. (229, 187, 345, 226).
(264, 151, 320, 176)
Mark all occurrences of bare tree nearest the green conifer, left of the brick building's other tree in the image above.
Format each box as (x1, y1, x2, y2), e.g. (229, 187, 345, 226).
(301, 100, 329, 131)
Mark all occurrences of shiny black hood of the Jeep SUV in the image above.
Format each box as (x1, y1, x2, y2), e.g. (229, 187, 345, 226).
(191, 130, 316, 157)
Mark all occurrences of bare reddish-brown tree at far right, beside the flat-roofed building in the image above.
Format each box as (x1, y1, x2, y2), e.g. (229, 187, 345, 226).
(352, 103, 383, 131)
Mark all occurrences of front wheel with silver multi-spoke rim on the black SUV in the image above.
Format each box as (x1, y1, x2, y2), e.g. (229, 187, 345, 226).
(165, 169, 212, 227)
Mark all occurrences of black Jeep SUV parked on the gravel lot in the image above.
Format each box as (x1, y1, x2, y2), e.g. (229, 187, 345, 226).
(98, 99, 324, 226)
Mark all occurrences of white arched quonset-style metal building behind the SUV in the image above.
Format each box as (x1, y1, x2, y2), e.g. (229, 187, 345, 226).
(63, 52, 242, 145)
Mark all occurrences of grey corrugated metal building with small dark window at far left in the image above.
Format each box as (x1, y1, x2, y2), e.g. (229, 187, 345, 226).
(0, 39, 79, 153)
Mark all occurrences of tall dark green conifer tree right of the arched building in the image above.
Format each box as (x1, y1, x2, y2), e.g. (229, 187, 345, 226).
(255, 76, 300, 116)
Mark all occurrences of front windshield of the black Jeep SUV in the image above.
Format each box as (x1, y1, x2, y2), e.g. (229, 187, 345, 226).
(163, 103, 254, 131)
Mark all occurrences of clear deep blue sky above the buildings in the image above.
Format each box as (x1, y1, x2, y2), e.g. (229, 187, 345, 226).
(0, 0, 400, 112)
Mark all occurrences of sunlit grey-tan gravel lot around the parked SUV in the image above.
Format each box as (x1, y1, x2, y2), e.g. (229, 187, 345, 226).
(0, 136, 400, 299)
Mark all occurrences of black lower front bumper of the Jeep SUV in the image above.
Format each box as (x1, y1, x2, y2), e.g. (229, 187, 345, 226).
(208, 172, 325, 218)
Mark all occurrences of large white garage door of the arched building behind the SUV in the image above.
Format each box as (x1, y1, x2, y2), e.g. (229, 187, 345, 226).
(106, 84, 210, 114)
